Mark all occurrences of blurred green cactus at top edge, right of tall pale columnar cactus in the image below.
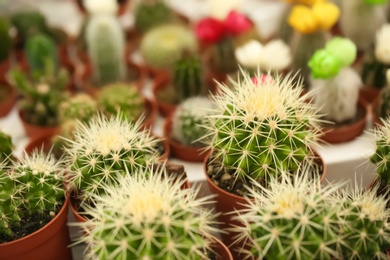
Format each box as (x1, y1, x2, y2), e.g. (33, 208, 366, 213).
(134, 0, 173, 33)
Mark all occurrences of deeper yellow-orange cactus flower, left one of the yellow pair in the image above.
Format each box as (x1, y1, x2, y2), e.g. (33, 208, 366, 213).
(288, 5, 319, 34)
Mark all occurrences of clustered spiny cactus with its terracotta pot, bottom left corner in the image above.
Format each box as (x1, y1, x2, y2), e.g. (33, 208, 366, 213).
(0, 150, 71, 259)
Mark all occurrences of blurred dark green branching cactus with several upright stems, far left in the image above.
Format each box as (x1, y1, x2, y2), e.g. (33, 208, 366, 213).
(10, 60, 68, 126)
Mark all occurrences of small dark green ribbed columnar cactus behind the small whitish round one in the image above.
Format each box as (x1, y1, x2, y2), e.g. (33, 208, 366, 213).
(173, 56, 207, 102)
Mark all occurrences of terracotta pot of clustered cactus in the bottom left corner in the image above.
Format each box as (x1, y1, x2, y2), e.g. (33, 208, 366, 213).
(0, 196, 72, 260)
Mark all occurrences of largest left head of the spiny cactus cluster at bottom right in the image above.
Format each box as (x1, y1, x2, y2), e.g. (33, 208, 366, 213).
(232, 169, 340, 260)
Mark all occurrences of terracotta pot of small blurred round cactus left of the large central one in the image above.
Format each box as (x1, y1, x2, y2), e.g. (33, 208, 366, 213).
(163, 114, 207, 162)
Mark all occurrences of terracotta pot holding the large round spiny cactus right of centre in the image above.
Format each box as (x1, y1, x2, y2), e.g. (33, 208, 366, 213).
(203, 149, 326, 259)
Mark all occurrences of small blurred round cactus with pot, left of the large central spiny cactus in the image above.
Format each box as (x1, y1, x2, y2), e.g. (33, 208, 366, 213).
(163, 96, 218, 162)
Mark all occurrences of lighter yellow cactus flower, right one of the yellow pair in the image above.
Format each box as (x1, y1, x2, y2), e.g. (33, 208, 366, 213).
(312, 2, 340, 30)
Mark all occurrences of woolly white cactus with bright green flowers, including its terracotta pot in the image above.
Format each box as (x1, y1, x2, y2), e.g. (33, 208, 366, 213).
(308, 37, 368, 143)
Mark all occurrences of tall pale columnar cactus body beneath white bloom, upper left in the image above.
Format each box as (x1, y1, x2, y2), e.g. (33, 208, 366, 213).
(86, 14, 126, 86)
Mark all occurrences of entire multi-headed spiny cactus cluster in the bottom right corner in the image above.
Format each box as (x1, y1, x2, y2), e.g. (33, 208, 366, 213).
(233, 170, 390, 259)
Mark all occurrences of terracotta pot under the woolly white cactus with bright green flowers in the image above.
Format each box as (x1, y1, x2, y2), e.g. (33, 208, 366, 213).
(321, 98, 368, 144)
